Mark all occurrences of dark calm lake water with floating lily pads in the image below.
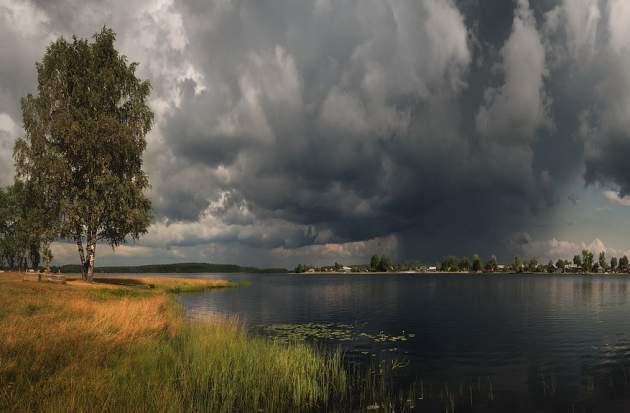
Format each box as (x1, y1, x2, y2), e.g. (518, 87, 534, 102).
(173, 274, 630, 412)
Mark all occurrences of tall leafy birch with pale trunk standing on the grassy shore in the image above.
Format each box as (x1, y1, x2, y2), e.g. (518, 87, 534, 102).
(14, 28, 153, 281)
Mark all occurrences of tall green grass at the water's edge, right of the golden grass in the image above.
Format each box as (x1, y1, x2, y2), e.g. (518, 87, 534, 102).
(102, 318, 347, 412)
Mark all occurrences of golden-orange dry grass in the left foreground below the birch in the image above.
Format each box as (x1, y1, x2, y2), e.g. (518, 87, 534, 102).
(0, 273, 178, 411)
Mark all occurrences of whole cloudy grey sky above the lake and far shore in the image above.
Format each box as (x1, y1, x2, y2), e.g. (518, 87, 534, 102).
(0, 0, 630, 266)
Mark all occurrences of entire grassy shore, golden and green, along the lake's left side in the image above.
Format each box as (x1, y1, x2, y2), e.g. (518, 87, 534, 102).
(0, 273, 404, 412)
